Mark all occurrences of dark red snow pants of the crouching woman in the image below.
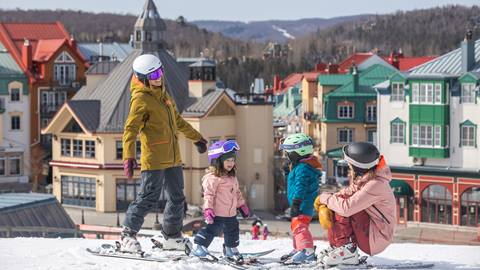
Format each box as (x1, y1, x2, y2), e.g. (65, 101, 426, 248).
(328, 210, 372, 255)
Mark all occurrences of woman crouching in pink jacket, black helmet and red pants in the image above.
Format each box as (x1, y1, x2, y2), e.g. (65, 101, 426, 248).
(315, 142, 397, 266)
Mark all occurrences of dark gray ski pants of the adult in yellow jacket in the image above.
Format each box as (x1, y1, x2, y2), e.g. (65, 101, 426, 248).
(123, 167, 185, 238)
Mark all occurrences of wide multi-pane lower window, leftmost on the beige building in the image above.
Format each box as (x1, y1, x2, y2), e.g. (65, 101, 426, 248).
(60, 175, 96, 207)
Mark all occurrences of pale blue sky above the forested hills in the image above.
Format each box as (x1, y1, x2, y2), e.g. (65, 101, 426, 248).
(0, 0, 480, 21)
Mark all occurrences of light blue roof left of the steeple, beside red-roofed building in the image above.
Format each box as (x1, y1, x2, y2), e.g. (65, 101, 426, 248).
(78, 42, 133, 61)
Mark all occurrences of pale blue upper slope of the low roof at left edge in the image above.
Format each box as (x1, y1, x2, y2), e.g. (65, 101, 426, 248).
(0, 193, 56, 212)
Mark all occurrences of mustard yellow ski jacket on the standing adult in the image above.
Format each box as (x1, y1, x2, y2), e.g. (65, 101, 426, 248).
(123, 76, 202, 171)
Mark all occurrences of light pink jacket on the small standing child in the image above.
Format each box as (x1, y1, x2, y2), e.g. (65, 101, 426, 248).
(202, 173, 245, 217)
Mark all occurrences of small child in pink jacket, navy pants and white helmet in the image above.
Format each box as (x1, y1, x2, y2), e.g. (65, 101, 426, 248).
(192, 140, 250, 263)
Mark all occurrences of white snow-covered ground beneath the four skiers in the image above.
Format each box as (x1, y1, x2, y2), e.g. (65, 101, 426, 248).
(0, 237, 480, 270)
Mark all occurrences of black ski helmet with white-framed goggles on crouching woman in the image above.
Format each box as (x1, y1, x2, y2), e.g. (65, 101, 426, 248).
(342, 142, 380, 171)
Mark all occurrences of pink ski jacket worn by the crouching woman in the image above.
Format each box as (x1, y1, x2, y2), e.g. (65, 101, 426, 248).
(320, 156, 397, 255)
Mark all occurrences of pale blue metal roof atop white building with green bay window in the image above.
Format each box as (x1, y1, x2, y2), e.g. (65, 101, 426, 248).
(410, 39, 480, 75)
